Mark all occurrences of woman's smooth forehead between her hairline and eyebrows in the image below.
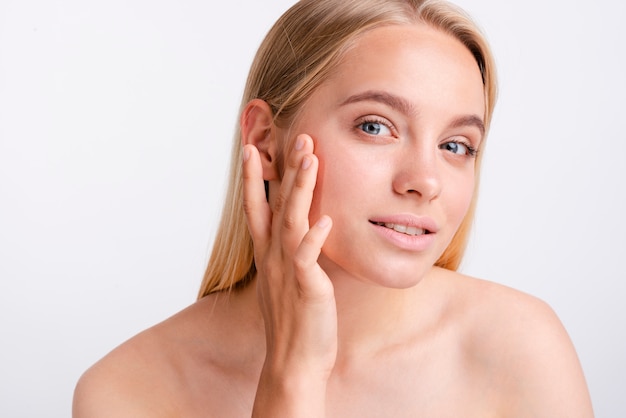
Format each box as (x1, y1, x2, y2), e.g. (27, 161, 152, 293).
(320, 24, 484, 117)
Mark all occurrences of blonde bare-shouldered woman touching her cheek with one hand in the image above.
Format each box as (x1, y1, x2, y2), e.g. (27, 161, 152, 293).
(74, 0, 593, 417)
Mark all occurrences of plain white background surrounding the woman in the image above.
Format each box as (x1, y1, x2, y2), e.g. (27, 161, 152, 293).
(0, 0, 626, 418)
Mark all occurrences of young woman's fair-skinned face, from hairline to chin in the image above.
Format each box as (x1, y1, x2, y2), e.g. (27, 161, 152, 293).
(282, 25, 485, 288)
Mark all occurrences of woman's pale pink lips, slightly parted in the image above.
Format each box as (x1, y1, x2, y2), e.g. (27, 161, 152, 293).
(369, 214, 439, 252)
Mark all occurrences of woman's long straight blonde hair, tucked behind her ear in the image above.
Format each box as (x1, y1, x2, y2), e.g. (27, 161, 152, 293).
(198, 0, 496, 298)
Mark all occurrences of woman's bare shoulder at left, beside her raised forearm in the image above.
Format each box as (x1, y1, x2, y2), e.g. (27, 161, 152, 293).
(73, 288, 263, 418)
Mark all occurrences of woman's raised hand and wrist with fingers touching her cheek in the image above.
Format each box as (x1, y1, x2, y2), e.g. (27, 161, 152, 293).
(243, 135, 337, 417)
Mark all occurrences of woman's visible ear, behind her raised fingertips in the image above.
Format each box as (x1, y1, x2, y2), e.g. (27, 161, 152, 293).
(239, 99, 279, 180)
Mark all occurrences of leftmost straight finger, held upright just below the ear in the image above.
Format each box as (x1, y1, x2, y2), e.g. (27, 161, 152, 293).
(243, 144, 272, 248)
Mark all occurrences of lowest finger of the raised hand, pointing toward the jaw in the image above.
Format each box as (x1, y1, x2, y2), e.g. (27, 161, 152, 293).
(293, 215, 332, 300)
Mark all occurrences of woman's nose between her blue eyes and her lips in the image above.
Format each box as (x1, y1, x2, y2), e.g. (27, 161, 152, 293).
(393, 146, 441, 201)
